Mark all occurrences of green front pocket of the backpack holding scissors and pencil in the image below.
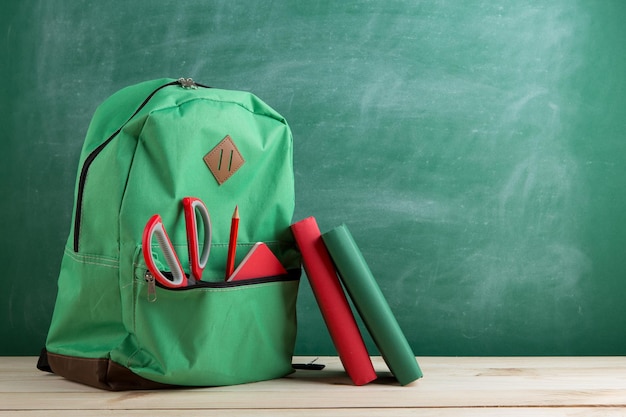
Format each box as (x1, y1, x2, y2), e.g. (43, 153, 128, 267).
(112, 254, 299, 386)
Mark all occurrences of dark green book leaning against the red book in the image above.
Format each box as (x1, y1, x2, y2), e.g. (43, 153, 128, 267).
(322, 225, 422, 385)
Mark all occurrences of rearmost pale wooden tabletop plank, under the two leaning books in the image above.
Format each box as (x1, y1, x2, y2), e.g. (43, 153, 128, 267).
(6, 357, 626, 392)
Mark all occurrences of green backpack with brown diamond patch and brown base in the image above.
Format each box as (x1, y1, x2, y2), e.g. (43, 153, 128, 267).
(39, 79, 300, 390)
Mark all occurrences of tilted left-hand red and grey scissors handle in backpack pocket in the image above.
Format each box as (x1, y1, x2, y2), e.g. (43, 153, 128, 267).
(141, 214, 188, 288)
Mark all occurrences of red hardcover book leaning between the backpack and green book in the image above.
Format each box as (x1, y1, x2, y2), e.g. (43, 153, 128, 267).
(291, 217, 376, 385)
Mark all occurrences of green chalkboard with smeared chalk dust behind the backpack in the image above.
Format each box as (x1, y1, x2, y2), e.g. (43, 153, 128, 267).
(0, 0, 626, 355)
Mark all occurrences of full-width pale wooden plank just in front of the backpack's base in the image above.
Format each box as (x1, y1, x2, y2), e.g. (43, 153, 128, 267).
(0, 389, 626, 410)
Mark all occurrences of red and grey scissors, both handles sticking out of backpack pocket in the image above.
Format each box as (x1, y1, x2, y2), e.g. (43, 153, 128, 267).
(141, 197, 211, 288)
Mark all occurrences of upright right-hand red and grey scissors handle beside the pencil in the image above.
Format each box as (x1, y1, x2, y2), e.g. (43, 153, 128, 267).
(183, 197, 212, 281)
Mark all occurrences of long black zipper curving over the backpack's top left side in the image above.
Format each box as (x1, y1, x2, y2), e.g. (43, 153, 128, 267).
(74, 78, 210, 252)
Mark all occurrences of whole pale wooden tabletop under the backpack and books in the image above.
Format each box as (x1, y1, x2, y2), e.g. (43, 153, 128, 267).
(0, 357, 626, 417)
